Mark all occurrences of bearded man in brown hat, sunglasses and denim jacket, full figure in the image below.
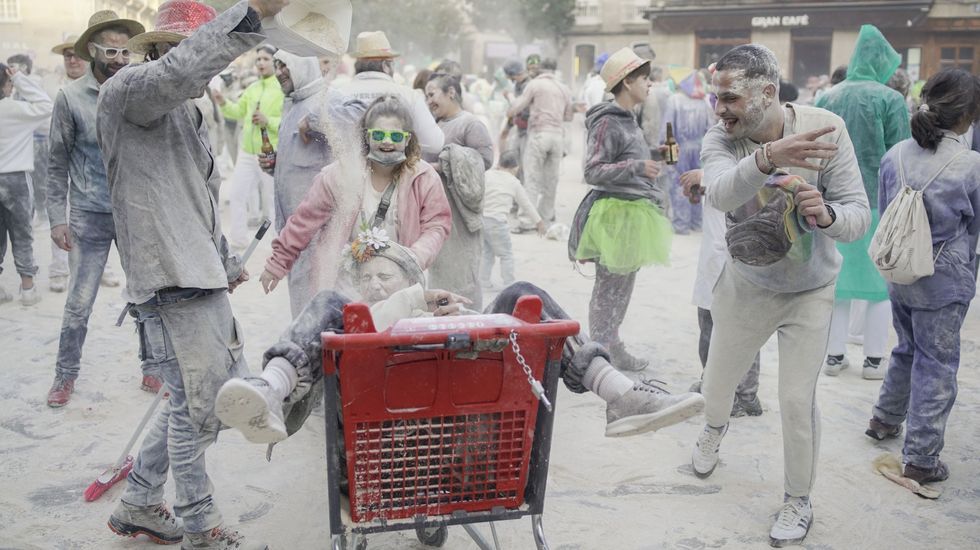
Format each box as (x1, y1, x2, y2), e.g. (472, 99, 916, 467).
(47, 10, 150, 407)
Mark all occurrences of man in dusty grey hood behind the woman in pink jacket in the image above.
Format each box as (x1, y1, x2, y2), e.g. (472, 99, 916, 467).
(259, 50, 365, 317)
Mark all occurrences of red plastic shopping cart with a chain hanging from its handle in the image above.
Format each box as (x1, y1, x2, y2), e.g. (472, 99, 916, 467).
(322, 296, 579, 550)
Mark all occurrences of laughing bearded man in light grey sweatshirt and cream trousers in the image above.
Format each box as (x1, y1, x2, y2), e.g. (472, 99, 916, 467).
(692, 44, 870, 546)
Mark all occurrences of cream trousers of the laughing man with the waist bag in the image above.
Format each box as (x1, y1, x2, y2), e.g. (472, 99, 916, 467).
(701, 263, 834, 497)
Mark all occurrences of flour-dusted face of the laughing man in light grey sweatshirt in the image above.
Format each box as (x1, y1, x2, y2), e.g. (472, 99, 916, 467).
(712, 70, 775, 139)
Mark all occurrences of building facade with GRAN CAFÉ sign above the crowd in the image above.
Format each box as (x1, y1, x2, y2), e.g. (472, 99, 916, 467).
(561, 0, 980, 85)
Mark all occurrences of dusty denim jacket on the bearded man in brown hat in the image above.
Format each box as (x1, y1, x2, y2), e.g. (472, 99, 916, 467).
(46, 69, 112, 227)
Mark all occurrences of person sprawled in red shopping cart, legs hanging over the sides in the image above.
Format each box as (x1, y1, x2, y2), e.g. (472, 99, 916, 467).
(215, 228, 704, 443)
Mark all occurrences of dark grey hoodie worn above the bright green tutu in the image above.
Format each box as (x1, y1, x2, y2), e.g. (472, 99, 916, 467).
(585, 101, 669, 210)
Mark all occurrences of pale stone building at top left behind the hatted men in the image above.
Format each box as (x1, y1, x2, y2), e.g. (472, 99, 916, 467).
(0, 0, 162, 70)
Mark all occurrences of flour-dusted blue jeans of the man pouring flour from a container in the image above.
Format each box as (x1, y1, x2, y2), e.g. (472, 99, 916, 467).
(122, 289, 247, 533)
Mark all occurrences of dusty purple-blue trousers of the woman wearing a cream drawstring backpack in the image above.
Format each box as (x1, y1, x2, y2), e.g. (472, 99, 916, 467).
(872, 299, 969, 468)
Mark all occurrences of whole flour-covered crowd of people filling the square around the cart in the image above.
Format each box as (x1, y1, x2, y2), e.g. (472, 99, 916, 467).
(0, 0, 980, 549)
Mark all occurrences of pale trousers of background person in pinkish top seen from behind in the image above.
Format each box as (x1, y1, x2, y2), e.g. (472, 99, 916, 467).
(521, 132, 565, 227)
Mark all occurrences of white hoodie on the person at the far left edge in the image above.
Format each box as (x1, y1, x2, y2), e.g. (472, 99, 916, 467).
(0, 73, 54, 174)
